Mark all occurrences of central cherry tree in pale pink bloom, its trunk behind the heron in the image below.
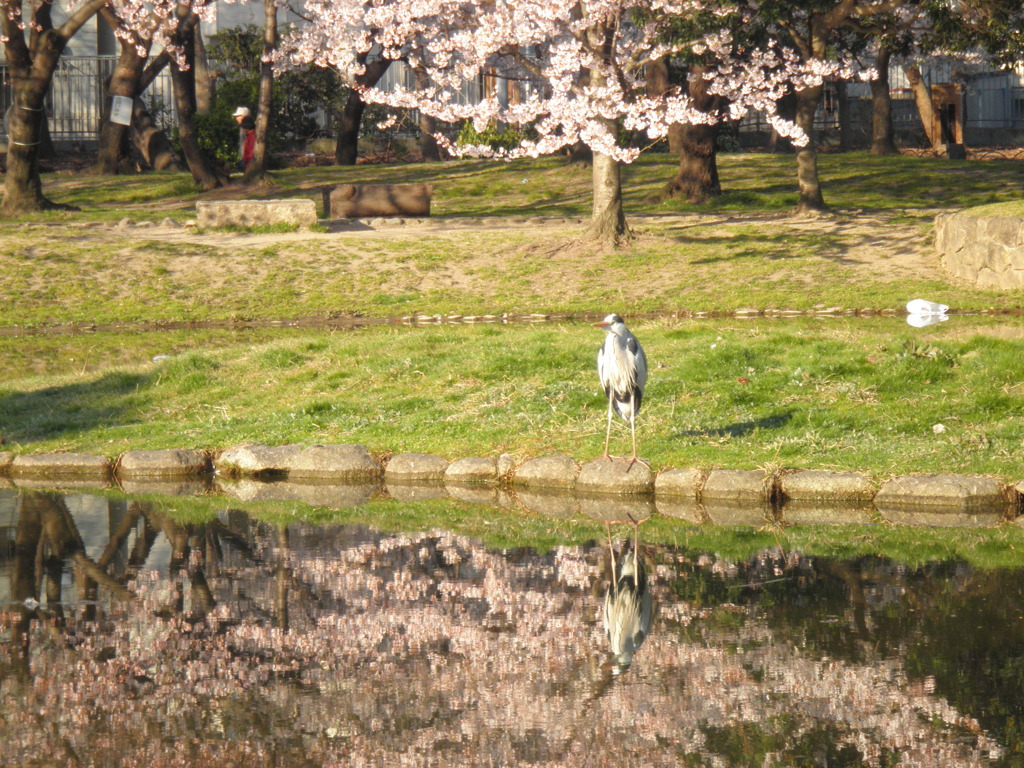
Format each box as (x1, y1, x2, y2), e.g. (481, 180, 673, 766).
(288, 0, 834, 242)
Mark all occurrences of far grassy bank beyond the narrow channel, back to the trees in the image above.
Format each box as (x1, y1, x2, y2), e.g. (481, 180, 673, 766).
(0, 154, 1024, 327)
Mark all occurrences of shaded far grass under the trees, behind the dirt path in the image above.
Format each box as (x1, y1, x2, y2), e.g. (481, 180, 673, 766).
(20, 153, 1024, 222)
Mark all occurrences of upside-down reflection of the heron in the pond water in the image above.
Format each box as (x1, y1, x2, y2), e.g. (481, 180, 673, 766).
(604, 515, 651, 675)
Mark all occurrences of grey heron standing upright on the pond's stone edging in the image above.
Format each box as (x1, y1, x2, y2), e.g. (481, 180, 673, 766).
(594, 314, 647, 469)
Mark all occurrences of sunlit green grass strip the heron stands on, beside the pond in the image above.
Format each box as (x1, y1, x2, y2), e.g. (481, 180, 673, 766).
(0, 317, 1024, 482)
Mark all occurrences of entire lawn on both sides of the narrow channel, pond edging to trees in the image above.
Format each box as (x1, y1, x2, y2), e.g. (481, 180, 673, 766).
(6, 154, 1024, 481)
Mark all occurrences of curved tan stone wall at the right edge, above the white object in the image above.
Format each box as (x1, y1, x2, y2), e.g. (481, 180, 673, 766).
(935, 213, 1024, 291)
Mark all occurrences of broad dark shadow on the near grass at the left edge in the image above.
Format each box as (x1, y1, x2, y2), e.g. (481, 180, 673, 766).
(0, 373, 152, 443)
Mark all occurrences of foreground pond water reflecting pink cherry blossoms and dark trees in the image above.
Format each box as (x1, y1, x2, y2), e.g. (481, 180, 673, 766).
(0, 490, 1024, 767)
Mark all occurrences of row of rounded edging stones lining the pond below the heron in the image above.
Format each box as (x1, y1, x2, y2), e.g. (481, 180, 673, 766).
(0, 443, 1024, 521)
